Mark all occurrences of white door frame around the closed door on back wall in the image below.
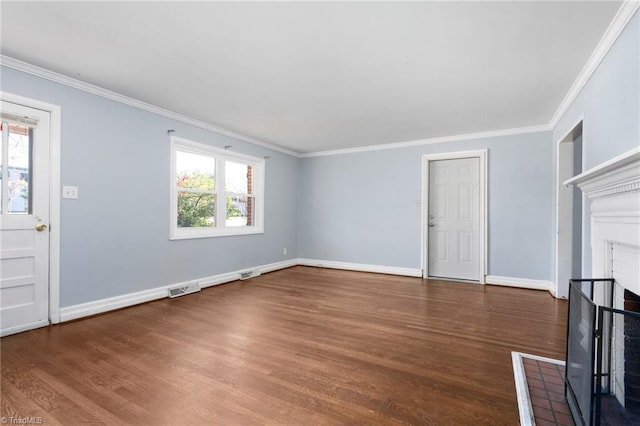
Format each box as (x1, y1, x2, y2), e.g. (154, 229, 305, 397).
(420, 149, 488, 284)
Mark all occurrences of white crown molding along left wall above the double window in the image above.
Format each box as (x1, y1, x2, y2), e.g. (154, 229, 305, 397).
(0, 55, 299, 157)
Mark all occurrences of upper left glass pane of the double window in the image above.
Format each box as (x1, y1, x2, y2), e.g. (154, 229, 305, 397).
(176, 151, 216, 190)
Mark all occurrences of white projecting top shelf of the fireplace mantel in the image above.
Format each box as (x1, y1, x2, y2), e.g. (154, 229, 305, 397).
(564, 147, 640, 198)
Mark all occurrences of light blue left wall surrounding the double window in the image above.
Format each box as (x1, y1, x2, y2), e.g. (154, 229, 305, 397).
(1, 67, 299, 307)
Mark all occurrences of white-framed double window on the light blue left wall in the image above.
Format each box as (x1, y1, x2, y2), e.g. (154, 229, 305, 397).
(170, 137, 264, 240)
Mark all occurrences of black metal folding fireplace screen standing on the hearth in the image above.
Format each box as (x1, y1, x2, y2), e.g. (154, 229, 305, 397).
(565, 279, 640, 426)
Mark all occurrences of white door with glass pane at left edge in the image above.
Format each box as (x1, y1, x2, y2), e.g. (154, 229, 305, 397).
(0, 101, 50, 336)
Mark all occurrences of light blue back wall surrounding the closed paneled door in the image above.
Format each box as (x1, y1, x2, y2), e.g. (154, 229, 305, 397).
(298, 132, 552, 280)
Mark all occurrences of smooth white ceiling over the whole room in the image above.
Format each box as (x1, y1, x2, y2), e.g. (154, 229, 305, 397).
(0, 1, 620, 153)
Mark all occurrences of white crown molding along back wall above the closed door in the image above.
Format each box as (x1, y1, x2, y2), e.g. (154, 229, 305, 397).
(299, 124, 552, 158)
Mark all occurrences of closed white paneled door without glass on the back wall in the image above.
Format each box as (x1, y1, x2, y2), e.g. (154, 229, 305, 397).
(427, 157, 482, 281)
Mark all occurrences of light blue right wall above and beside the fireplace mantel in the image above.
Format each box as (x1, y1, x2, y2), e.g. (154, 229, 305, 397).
(550, 12, 640, 276)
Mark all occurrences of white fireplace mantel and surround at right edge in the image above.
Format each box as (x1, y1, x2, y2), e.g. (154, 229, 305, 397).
(564, 147, 640, 295)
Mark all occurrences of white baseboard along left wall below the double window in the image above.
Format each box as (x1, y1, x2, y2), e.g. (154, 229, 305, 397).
(60, 259, 298, 322)
